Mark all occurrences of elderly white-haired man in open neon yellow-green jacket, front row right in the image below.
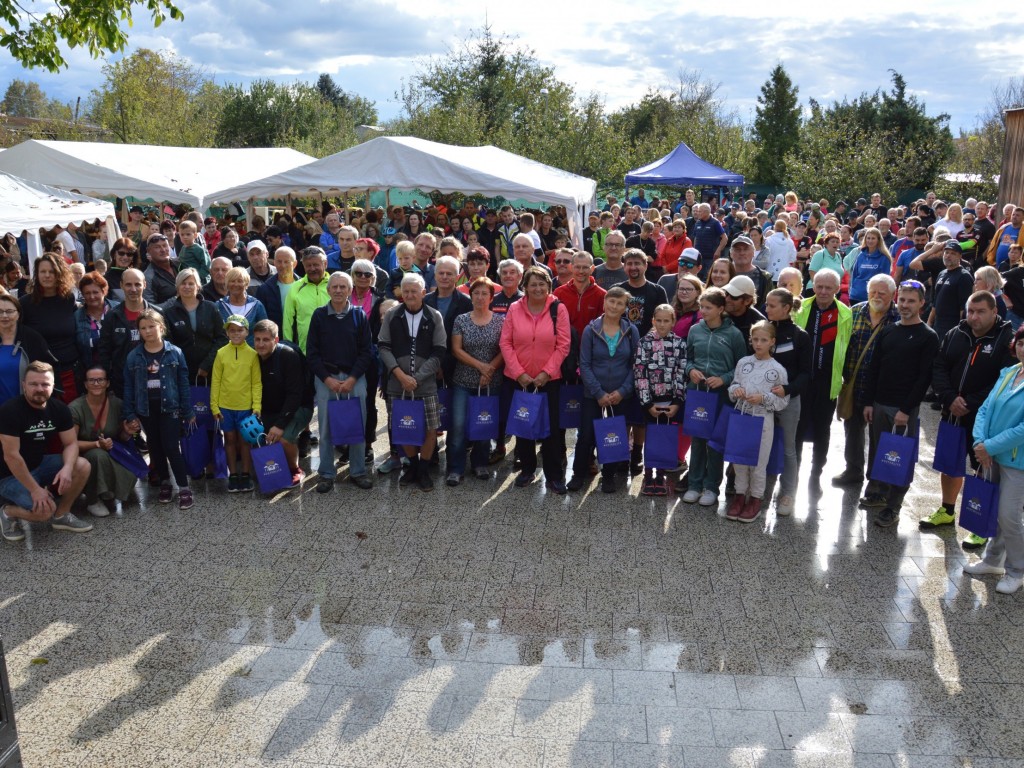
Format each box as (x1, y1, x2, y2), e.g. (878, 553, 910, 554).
(794, 269, 853, 478)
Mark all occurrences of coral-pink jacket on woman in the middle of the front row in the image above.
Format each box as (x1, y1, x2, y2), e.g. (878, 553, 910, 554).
(500, 296, 570, 381)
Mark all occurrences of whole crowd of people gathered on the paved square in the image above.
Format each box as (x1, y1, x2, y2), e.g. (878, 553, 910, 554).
(0, 190, 1024, 592)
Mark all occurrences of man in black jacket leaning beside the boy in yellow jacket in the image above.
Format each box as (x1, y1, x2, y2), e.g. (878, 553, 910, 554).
(253, 319, 313, 487)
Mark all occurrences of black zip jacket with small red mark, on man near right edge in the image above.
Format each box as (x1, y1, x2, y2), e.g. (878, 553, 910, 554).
(932, 321, 1014, 413)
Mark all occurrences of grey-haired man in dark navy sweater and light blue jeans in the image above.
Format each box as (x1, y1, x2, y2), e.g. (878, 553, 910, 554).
(306, 271, 374, 494)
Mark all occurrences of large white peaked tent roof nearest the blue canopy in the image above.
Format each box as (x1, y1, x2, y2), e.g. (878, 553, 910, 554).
(204, 136, 597, 208)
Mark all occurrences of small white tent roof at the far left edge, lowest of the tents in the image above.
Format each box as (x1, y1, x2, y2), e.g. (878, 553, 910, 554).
(0, 173, 114, 234)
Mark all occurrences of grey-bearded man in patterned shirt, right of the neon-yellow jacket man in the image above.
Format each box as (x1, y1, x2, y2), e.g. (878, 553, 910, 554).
(833, 274, 901, 487)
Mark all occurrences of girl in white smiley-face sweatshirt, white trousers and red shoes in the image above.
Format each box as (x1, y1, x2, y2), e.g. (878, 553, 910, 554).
(725, 321, 790, 522)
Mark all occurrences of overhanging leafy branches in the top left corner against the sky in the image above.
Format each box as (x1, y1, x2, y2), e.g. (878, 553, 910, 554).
(0, 0, 184, 72)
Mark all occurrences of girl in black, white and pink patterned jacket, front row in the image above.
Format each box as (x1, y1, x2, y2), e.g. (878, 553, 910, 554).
(633, 304, 686, 496)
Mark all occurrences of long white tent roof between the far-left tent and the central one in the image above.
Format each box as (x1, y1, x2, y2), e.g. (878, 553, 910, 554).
(0, 139, 314, 209)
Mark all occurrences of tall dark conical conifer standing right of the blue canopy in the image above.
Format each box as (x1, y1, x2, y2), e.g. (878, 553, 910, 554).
(753, 63, 800, 186)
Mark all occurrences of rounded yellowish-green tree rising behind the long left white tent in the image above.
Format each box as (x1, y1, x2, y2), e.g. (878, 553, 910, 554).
(89, 48, 222, 146)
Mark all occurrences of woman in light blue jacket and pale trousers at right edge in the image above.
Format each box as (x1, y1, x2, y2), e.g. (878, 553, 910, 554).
(964, 328, 1024, 595)
